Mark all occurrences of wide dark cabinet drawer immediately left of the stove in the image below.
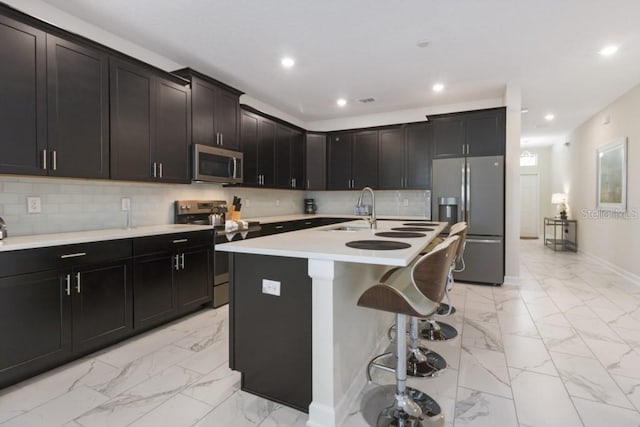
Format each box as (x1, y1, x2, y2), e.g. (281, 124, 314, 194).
(133, 229, 213, 257)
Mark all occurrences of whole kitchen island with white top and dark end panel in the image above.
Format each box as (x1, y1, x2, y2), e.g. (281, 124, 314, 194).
(216, 220, 445, 426)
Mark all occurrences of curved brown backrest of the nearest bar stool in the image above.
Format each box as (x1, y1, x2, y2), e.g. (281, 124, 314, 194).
(411, 236, 460, 303)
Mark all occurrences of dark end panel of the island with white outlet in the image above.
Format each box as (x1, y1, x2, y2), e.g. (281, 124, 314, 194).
(229, 253, 312, 412)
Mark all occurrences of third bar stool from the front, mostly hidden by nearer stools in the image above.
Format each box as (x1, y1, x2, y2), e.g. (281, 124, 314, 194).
(420, 222, 468, 341)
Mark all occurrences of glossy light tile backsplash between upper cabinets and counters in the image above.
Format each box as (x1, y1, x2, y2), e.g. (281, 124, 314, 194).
(0, 175, 428, 236)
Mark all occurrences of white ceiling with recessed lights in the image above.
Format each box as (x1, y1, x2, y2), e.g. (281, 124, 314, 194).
(33, 0, 640, 144)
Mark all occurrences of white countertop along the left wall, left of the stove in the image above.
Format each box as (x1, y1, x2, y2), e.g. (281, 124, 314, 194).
(0, 224, 211, 252)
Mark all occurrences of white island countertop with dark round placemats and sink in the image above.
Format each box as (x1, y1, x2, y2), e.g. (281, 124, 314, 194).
(216, 220, 446, 267)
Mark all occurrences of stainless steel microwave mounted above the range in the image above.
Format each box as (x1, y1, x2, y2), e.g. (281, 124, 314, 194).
(193, 144, 243, 183)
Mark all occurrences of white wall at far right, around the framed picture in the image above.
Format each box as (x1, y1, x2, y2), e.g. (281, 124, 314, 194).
(552, 85, 640, 277)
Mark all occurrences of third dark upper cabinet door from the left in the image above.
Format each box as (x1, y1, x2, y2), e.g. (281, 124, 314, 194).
(109, 58, 155, 181)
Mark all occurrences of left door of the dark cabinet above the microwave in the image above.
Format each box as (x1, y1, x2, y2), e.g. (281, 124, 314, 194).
(191, 77, 218, 146)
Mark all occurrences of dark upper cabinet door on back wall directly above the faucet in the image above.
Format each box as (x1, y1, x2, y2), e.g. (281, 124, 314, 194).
(352, 130, 378, 189)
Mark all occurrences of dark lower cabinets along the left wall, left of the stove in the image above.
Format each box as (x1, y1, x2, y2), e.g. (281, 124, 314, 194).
(0, 230, 213, 389)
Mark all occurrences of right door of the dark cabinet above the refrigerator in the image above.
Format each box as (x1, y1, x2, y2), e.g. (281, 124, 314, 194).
(465, 108, 507, 157)
